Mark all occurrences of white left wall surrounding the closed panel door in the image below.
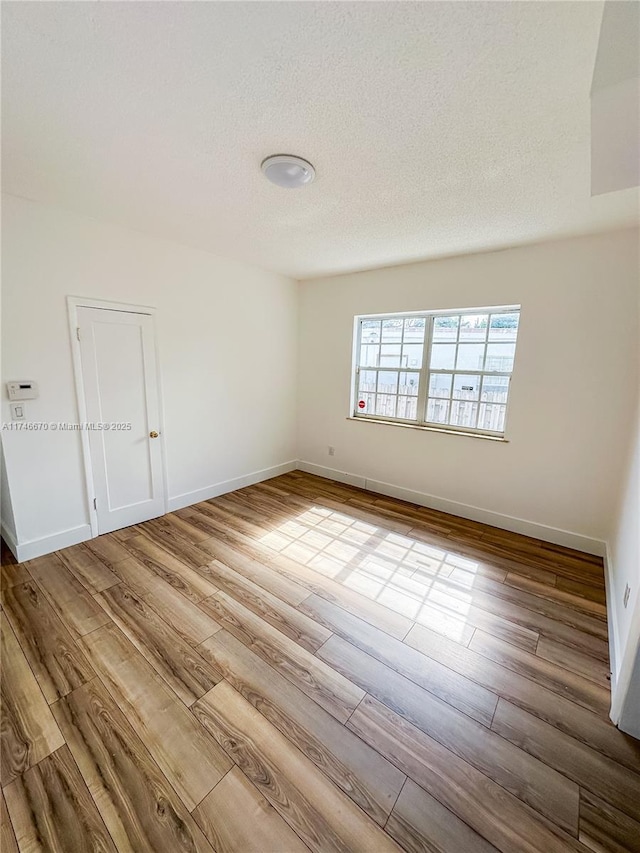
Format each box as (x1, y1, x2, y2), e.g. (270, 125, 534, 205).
(2, 196, 297, 550)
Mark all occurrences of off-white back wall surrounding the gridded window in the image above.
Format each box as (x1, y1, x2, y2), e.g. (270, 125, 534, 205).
(298, 231, 638, 551)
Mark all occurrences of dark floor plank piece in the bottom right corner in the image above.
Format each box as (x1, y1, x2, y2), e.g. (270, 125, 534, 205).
(578, 790, 640, 853)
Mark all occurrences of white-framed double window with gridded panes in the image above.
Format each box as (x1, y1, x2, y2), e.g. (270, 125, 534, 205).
(353, 306, 520, 436)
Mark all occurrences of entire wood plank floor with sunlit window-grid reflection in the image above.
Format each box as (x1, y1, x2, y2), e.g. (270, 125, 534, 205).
(0, 472, 640, 853)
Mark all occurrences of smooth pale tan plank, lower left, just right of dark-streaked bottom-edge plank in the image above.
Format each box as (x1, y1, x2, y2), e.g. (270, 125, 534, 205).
(82, 624, 231, 811)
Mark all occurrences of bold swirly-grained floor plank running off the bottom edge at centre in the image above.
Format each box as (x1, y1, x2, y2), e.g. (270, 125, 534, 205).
(193, 681, 400, 853)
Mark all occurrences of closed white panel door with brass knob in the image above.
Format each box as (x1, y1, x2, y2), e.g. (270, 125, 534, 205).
(78, 308, 165, 533)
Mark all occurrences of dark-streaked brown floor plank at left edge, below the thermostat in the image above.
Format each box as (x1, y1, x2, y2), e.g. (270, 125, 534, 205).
(3, 580, 95, 704)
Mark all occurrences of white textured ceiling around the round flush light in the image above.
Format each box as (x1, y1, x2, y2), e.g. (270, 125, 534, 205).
(2, 2, 638, 278)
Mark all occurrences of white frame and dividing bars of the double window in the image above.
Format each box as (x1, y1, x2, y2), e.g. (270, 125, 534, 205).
(350, 305, 521, 440)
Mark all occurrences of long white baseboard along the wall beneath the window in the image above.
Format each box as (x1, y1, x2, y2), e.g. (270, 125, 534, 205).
(298, 461, 606, 557)
